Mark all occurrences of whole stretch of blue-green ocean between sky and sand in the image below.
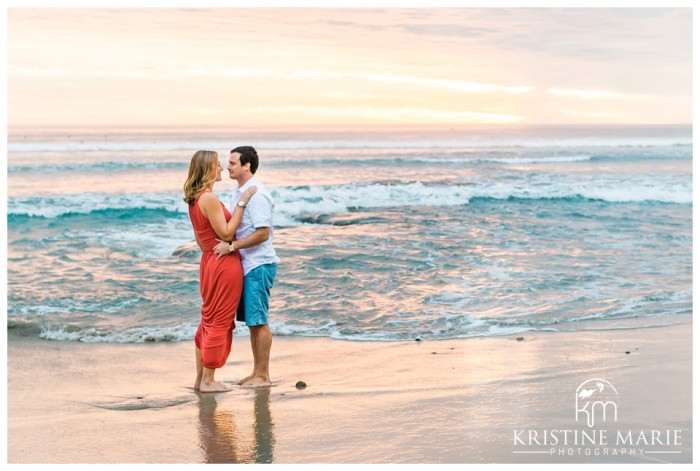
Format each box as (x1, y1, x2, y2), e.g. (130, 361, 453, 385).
(7, 125, 693, 343)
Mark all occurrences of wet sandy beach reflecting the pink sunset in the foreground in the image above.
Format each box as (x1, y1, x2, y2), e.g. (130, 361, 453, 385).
(7, 318, 693, 463)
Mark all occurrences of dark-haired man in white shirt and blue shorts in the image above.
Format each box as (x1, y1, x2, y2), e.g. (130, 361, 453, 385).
(214, 146, 279, 388)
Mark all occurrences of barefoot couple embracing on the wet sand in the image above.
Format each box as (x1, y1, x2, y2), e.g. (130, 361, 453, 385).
(184, 146, 279, 392)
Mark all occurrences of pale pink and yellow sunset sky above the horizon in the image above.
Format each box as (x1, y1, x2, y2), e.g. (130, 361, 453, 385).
(7, 7, 692, 128)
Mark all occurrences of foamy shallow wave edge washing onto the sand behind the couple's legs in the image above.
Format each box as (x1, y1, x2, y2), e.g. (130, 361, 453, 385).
(8, 291, 692, 343)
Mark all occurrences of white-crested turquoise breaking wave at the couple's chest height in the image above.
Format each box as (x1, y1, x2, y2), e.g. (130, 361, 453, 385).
(7, 176, 692, 222)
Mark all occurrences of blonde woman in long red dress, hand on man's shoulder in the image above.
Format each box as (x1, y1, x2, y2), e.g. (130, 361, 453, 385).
(184, 150, 256, 392)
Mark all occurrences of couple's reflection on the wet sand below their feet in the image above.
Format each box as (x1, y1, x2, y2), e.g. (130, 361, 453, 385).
(199, 388, 275, 463)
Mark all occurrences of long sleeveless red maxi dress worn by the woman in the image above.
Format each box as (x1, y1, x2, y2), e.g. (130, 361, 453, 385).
(189, 193, 243, 369)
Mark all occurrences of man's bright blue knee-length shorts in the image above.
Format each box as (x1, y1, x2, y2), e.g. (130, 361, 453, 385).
(236, 263, 277, 327)
